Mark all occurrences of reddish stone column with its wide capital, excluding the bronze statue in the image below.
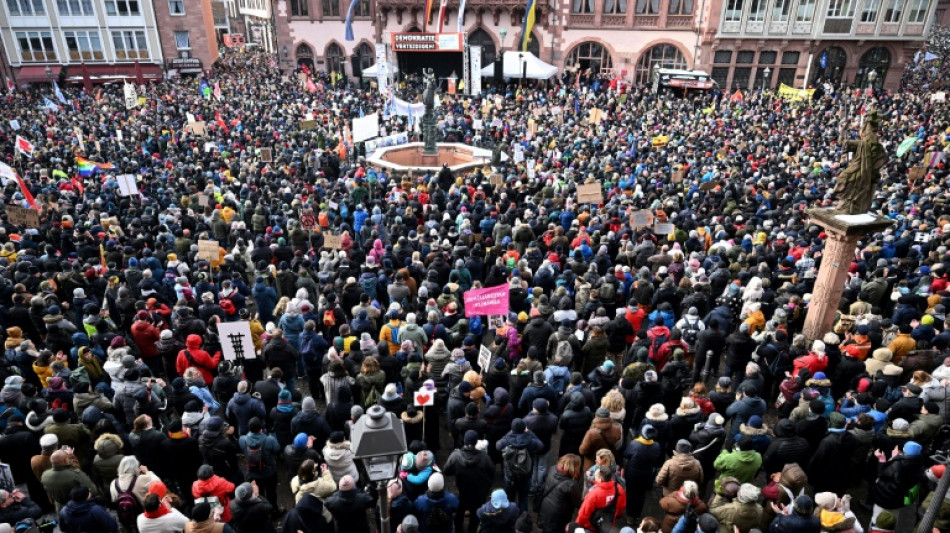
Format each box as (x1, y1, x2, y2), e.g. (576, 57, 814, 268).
(802, 209, 894, 346)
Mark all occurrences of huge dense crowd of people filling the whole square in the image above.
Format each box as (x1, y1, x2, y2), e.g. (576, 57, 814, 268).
(0, 42, 950, 533)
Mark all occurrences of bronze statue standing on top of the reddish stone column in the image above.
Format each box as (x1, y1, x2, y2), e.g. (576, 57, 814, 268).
(835, 110, 887, 215)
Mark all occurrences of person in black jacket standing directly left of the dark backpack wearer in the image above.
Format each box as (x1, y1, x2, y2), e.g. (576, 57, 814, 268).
(442, 430, 495, 533)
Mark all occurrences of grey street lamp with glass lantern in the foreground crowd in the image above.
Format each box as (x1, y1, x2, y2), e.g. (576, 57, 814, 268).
(350, 405, 406, 533)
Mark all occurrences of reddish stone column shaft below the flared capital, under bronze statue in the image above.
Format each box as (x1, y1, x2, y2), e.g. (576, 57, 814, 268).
(802, 229, 861, 338)
